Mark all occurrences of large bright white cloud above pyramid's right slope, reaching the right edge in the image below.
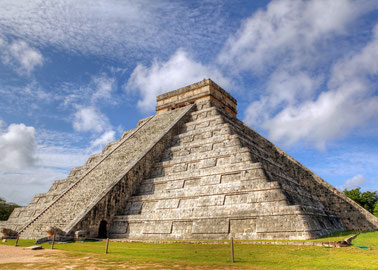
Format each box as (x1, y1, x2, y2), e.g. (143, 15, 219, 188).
(263, 25, 378, 148)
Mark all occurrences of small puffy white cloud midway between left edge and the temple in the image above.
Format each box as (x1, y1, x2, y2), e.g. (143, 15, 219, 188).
(72, 107, 110, 132)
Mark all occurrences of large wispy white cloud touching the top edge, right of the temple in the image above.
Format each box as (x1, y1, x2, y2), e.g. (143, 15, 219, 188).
(218, 0, 373, 72)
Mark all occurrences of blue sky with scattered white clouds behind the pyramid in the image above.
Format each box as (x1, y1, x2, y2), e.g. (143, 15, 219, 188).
(0, 0, 378, 205)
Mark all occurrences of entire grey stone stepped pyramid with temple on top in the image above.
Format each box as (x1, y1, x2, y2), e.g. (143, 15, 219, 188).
(0, 79, 378, 239)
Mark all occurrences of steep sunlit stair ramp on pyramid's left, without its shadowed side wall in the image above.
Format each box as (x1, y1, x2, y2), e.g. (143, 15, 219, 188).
(20, 105, 190, 239)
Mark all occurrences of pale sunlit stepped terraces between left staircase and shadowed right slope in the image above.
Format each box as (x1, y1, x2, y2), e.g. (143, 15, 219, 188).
(110, 106, 342, 239)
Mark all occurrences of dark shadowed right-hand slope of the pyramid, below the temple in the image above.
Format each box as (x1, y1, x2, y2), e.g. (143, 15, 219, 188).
(221, 109, 378, 230)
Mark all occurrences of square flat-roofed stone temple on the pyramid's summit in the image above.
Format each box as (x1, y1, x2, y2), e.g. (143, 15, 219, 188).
(156, 79, 237, 117)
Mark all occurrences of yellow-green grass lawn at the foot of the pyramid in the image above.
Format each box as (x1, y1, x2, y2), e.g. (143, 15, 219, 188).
(0, 232, 378, 269)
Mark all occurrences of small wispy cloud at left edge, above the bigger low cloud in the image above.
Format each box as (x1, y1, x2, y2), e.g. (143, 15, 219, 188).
(0, 37, 43, 74)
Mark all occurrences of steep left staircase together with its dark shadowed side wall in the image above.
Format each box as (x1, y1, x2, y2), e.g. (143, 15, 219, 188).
(12, 104, 193, 238)
